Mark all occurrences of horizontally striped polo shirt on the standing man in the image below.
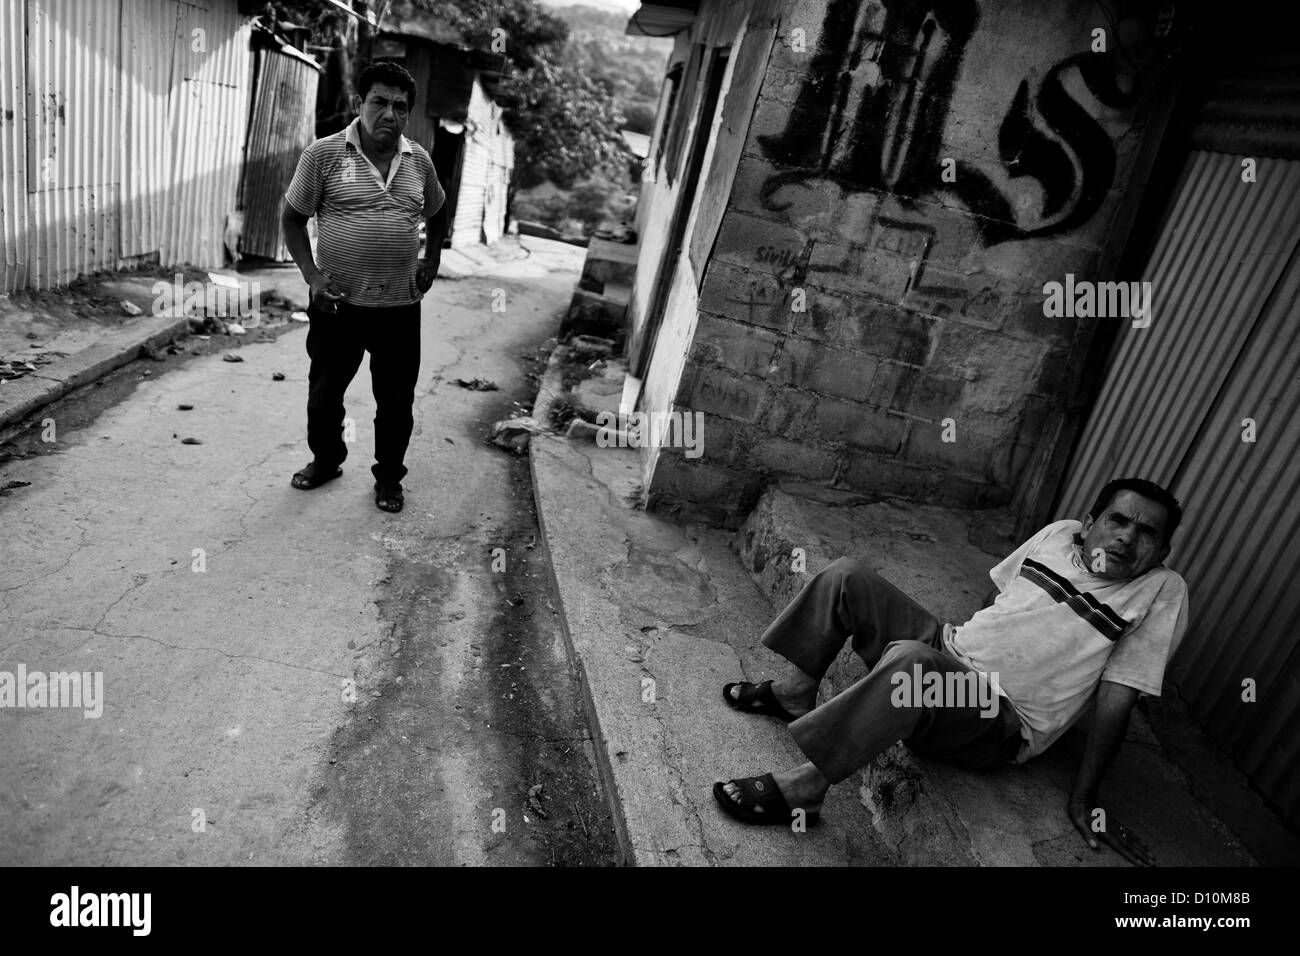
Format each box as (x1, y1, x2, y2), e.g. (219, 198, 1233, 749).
(285, 118, 446, 308)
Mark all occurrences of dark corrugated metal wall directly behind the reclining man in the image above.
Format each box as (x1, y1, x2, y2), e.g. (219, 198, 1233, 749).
(1057, 151, 1300, 825)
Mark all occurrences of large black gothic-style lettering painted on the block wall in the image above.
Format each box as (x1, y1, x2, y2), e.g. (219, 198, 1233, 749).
(759, 0, 1138, 246)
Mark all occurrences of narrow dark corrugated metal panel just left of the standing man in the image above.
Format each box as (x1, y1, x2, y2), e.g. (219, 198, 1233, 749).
(239, 48, 320, 261)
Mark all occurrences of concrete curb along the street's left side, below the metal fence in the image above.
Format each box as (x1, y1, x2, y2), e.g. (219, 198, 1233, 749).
(0, 316, 190, 428)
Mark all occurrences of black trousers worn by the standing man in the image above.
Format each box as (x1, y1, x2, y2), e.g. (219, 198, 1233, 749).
(307, 302, 420, 481)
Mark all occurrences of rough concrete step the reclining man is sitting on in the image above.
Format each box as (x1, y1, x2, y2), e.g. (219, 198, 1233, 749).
(735, 485, 1251, 866)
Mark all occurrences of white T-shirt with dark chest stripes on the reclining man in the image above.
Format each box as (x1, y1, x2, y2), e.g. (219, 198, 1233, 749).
(944, 520, 1187, 761)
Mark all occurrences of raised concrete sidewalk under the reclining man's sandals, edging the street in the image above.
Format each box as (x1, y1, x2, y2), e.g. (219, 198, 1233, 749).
(529, 351, 885, 866)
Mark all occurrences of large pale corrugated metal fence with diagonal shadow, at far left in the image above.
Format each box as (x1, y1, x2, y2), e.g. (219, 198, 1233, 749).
(0, 0, 251, 291)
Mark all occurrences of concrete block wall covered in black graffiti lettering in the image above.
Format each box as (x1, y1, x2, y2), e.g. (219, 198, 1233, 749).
(647, 0, 1151, 525)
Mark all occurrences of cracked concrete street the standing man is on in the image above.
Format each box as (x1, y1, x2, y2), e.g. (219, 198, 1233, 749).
(0, 239, 615, 865)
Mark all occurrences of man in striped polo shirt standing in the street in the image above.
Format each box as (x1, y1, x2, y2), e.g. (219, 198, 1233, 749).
(281, 62, 447, 511)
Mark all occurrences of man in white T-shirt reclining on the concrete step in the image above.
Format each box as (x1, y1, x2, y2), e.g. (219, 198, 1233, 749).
(714, 479, 1187, 864)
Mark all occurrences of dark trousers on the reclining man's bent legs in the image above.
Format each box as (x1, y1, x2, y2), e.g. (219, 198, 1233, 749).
(763, 558, 1021, 783)
